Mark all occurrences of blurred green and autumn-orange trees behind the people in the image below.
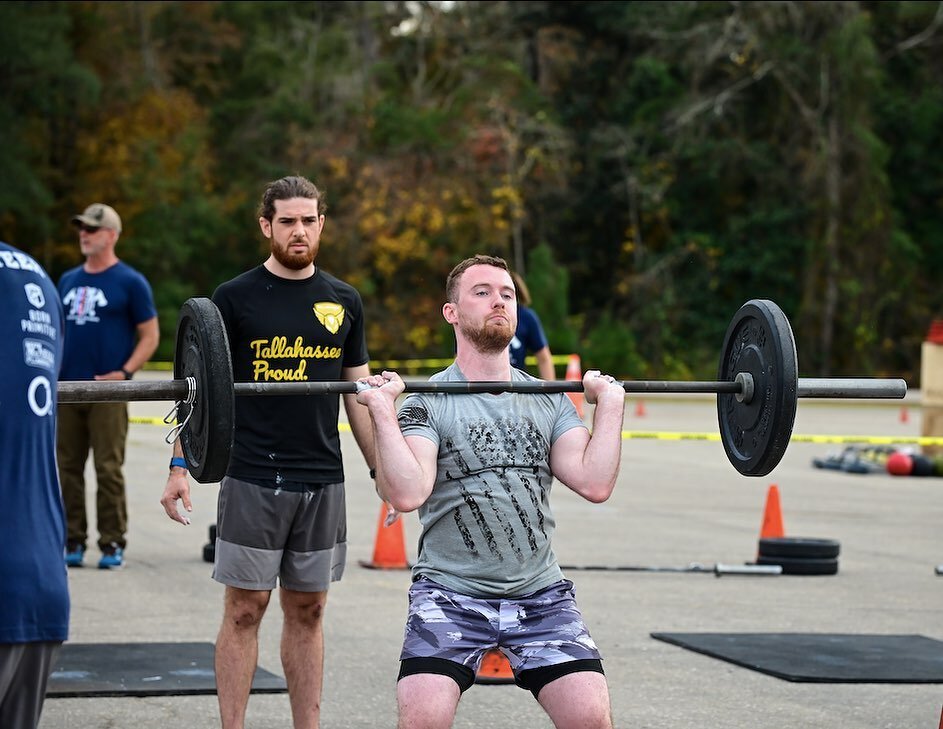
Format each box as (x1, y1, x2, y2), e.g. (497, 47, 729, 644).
(0, 1, 943, 385)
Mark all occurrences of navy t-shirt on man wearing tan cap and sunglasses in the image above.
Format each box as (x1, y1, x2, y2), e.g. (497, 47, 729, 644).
(59, 261, 157, 380)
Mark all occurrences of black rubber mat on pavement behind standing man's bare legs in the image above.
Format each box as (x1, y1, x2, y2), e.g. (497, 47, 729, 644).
(46, 643, 287, 698)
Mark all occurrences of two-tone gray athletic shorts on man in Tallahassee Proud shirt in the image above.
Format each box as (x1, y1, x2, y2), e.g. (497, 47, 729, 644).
(213, 476, 347, 592)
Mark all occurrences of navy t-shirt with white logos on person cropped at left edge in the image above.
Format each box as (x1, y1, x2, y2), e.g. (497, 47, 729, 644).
(0, 242, 69, 643)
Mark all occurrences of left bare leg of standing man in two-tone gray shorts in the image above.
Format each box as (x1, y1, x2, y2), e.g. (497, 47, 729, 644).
(215, 586, 272, 729)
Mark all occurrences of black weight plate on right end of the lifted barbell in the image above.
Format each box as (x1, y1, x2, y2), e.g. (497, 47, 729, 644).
(717, 299, 799, 476)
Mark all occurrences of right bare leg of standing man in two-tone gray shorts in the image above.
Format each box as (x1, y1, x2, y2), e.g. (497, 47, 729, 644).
(279, 587, 327, 729)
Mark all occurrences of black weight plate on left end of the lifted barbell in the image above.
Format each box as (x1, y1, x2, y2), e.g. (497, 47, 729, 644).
(174, 298, 235, 483)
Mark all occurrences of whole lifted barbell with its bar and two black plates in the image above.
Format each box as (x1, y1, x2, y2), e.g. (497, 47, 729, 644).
(58, 297, 907, 483)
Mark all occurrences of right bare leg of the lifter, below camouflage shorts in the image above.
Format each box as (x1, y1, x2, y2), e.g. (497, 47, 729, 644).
(537, 671, 612, 729)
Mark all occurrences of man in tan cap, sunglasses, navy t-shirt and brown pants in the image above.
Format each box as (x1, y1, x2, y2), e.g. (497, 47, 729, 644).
(56, 203, 160, 569)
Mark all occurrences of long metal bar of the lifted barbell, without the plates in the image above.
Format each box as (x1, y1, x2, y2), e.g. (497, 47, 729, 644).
(59, 373, 907, 403)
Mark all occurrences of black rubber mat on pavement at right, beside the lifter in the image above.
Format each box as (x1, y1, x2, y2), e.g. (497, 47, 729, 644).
(651, 633, 943, 683)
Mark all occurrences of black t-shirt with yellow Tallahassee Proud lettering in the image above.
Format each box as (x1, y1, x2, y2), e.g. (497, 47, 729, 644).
(213, 266, 369, 484)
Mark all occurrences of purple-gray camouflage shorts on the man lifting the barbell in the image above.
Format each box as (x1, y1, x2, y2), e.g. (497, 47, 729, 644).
(400, 577, 600, 675)
